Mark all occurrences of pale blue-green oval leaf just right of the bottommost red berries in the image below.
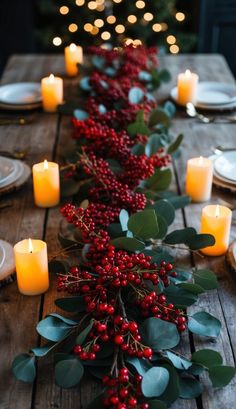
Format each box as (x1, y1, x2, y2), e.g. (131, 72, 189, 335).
(141, 367, 170, 398)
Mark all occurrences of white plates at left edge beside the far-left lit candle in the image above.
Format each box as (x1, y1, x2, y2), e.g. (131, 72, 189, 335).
(0, 82, 42, 105)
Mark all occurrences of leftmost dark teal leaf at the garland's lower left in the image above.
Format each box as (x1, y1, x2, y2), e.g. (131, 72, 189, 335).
(12, 354, 36, 382)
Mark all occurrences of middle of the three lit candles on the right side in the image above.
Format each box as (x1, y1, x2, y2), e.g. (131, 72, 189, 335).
(186, 156, 213, 202)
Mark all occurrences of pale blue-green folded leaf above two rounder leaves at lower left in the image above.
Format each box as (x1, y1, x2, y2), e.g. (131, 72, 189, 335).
(36, 316, 74, 342)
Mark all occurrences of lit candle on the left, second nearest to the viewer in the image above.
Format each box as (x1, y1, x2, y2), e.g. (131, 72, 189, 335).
(33, 160, 60, 207)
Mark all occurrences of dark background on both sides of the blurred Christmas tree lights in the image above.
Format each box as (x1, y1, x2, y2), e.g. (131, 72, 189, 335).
(0, 0, 236, 75)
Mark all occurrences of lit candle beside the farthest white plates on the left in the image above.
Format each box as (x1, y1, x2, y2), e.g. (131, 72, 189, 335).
(41, 74, 63, 112)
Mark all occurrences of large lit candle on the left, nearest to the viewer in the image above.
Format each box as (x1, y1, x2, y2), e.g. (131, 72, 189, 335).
(14, 239, 49, 295)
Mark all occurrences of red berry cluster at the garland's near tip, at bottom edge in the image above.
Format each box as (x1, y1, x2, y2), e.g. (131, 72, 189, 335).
(103, 367, 149, 409)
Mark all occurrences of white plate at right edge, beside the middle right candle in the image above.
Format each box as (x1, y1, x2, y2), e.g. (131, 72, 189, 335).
(214, 151, 236, 182)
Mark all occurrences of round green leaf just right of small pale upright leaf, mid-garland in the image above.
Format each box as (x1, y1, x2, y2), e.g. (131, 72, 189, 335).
(128, 209, 159, 240)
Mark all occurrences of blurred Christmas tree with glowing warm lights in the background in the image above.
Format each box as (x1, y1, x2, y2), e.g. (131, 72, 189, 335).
(37, 0, 195, 54)
